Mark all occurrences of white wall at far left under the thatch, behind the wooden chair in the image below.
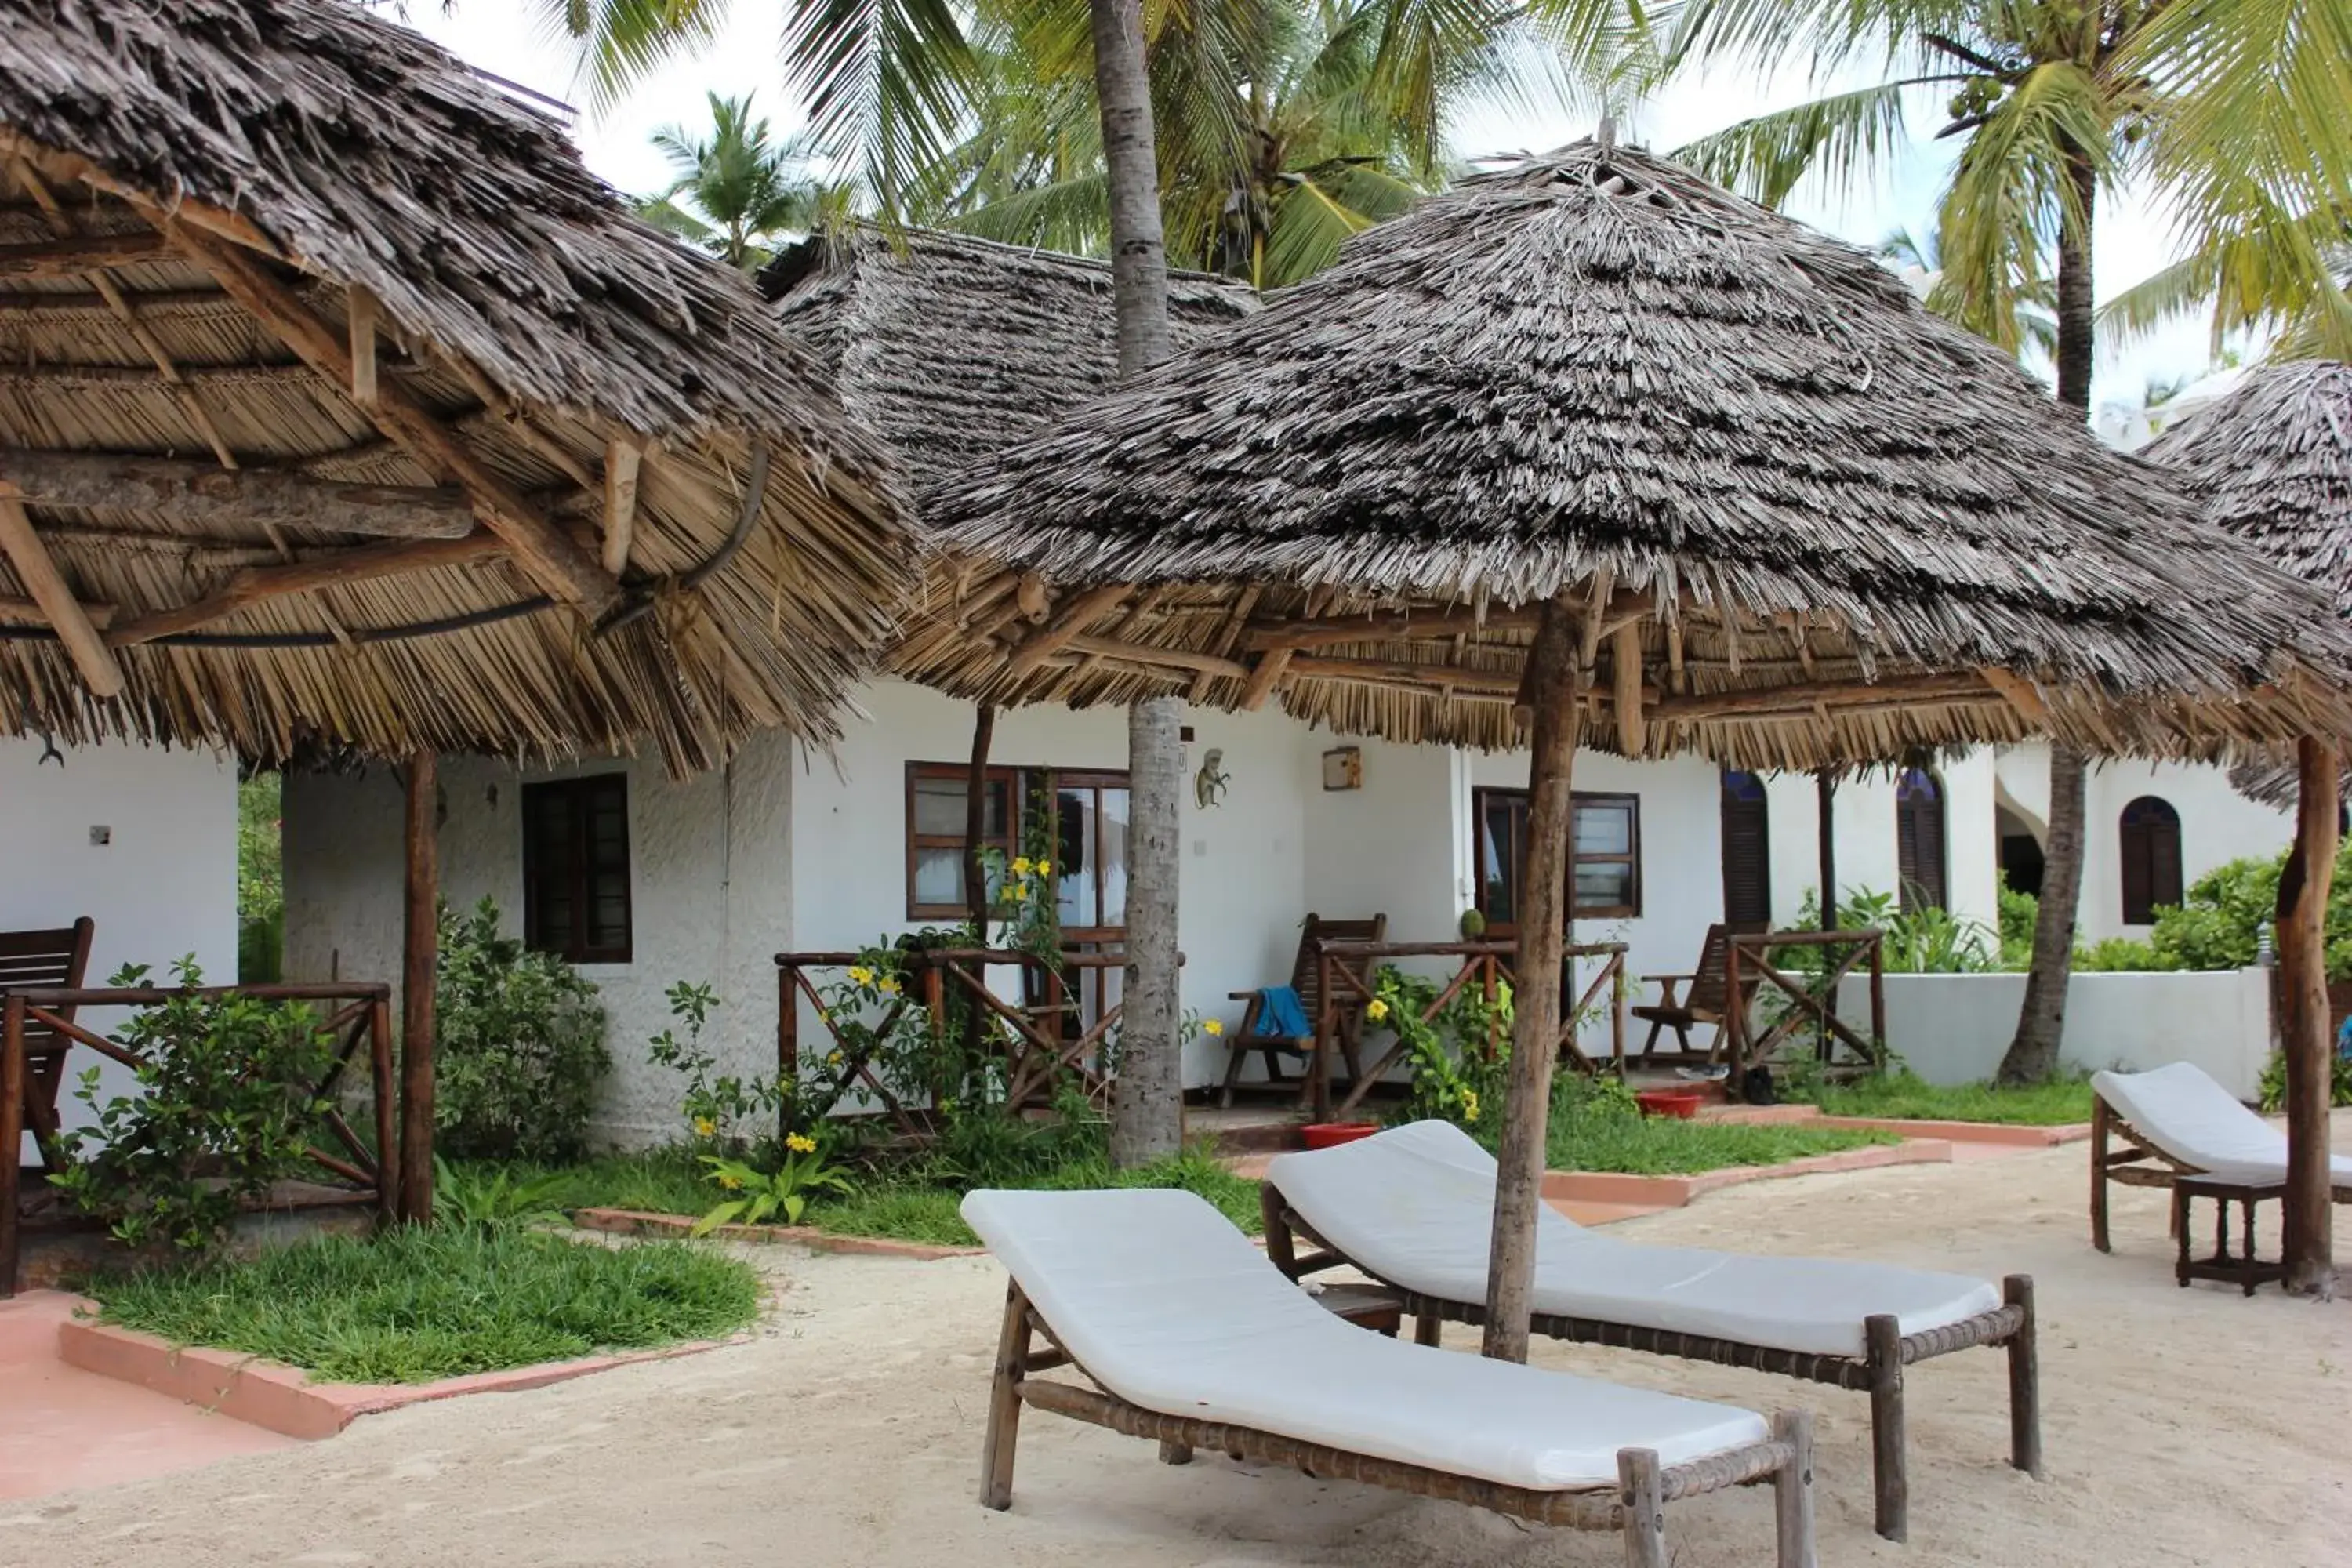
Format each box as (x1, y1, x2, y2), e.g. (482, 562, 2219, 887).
(0, 739, 238, 1147)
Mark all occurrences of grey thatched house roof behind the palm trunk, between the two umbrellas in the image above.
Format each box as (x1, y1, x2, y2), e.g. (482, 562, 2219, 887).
(760, 223, 1258, 492)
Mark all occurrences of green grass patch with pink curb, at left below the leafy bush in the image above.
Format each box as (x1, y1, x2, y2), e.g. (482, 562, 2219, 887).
(87, 1227, 760, 1382)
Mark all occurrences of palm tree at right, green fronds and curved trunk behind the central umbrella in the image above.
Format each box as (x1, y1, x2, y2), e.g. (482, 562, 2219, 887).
(1670, 0, 2352, 1081)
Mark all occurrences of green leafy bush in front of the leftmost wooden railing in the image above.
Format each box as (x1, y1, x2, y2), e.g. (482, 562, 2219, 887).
(49, 954, 334, 1250)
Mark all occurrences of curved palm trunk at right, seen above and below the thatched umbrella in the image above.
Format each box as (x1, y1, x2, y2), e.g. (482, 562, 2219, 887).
(1999, 155, 2098, 1083)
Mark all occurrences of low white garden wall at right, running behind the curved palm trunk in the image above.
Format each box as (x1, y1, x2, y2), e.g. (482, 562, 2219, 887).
(1837, 968, 2270, 1100)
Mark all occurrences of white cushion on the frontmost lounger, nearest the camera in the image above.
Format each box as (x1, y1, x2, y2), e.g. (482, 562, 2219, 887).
(964, 1189, 1769, 1490)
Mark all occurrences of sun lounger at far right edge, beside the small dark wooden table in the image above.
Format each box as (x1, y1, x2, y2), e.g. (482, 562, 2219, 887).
(2091, 1062, 2352, 1253)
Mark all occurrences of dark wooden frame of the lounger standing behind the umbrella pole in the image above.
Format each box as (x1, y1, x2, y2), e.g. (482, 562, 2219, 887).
(1258, 1180, 2042, 1540)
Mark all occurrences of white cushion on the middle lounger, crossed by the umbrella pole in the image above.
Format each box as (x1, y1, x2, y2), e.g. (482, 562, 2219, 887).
(1265, 1121, 2002, 1356)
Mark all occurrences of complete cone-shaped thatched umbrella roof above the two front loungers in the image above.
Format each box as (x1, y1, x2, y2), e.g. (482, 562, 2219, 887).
(901, 143, 2347, 769)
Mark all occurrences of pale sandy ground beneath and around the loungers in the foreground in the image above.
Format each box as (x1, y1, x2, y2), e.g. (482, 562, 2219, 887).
(0, 1142, 2352, 1568)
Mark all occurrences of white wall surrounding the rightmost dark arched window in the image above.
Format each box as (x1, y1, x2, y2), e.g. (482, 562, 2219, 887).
(1997, 743, 2296, 942)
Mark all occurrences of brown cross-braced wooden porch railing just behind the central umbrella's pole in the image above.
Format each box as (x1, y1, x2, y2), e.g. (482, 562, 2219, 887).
(1308, 938, 1625, 1121)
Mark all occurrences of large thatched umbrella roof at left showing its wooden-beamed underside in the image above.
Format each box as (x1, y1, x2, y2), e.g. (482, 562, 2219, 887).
(0, 0, 915, 769)
